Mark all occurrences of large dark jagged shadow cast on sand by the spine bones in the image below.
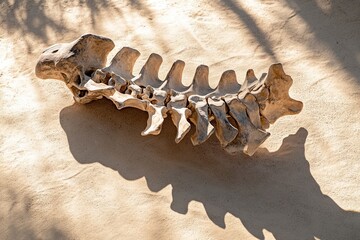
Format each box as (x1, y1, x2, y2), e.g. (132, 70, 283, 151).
(60, 100, 360, 239)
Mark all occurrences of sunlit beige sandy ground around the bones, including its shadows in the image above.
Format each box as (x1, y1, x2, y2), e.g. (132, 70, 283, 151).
(0, 0, 360, 239)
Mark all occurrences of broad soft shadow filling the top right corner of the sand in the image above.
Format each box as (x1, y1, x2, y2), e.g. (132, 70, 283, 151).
(287, 0, 360, 84)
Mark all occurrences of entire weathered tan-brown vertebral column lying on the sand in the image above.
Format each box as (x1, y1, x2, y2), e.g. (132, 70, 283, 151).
(35, 34, 303, 155)
